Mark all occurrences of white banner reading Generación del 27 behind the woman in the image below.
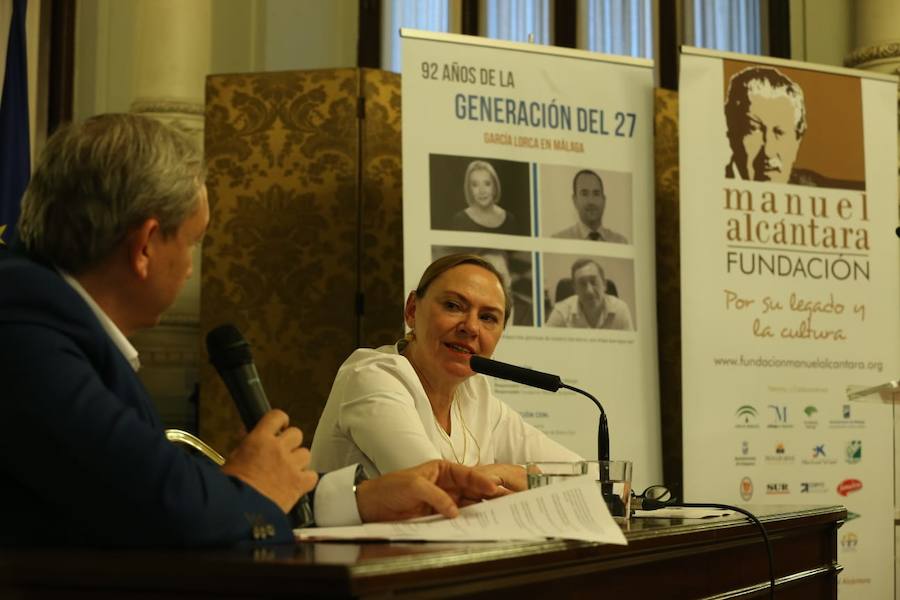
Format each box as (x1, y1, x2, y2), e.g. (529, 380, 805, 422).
(401, 30, 662, 485)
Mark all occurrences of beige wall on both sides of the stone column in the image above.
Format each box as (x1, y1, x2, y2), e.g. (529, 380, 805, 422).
(73, 0, 358, 119)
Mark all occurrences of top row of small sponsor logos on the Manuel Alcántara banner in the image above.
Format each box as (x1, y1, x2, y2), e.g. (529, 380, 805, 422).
(734, 404, 866, 429)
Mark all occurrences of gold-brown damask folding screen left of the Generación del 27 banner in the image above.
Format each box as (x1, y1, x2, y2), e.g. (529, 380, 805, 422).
(199, 69, 403, 453)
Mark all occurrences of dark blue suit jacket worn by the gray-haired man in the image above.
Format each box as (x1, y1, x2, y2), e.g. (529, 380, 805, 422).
(0, 248, 293, 546)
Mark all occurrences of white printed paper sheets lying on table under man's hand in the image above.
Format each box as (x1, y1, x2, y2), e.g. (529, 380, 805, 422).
(294, 476, 627, 545)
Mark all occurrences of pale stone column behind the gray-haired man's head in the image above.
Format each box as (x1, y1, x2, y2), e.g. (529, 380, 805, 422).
(131, 0, 212, 429)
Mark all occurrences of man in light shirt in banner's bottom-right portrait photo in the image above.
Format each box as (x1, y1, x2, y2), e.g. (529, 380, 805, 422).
(547, 258, 634, 331)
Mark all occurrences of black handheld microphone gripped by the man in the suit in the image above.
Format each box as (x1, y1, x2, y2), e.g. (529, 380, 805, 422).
(206, 324, 314, 527)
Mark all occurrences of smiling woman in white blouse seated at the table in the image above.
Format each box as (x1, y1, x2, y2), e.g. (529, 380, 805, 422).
(311, 254, 581, 490)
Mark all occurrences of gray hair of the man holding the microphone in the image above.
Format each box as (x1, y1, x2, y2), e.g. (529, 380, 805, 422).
(17, 114, 206, 274)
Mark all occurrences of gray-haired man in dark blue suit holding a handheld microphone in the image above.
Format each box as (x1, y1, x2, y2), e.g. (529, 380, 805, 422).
(0, 114, 497, 546)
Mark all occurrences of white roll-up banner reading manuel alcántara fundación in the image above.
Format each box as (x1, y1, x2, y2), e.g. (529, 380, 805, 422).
(679, 49, 900, 598)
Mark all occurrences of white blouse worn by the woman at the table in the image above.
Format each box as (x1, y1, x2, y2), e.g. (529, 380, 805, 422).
(311, 346, 582, 477)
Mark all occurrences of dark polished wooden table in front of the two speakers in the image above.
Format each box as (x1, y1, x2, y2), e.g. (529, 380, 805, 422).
(0, 506, 847, 600)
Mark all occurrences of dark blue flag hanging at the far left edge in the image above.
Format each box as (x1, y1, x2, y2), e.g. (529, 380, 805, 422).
(0, 0, 31, 244)
